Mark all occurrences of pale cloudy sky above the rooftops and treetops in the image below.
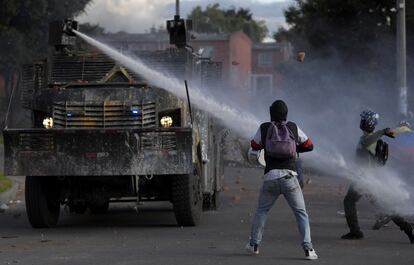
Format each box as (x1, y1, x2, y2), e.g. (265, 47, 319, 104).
(78, 0, 293, 36)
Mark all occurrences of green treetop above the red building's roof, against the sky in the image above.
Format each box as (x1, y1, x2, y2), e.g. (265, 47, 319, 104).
(188, 4, 268, 42)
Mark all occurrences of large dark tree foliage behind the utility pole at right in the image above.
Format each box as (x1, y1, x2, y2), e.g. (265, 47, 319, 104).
(274, 0, 414, 109)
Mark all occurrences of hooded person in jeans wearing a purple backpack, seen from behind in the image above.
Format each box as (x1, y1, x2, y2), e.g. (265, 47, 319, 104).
(246, 100, 318, 260)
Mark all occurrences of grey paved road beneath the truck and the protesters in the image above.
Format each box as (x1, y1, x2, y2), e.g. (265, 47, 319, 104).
(0, 168, 414, 265)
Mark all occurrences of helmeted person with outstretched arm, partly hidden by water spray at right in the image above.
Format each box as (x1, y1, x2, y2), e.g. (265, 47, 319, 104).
(341, 110, 414, 243)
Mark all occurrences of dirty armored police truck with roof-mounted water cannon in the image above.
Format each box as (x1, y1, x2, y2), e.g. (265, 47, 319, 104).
(3, 16, 223, 228)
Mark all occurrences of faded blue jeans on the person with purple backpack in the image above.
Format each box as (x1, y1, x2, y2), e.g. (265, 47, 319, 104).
(250, 176, 312, 250)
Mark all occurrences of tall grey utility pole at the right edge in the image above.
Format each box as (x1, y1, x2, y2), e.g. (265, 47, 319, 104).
(397, 0, 408, 117)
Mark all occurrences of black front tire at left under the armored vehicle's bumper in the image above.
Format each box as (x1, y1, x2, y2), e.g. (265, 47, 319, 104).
(25, 176, 60, 228)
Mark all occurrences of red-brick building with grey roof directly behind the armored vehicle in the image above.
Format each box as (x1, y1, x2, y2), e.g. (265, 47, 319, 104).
(99, 31, 252, 91)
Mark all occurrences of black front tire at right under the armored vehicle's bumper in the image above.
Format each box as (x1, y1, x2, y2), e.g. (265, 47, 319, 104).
(172, 174, 203, 226)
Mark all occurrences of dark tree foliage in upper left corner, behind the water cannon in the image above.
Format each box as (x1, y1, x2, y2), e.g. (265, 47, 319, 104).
(0, 0, 90, 73)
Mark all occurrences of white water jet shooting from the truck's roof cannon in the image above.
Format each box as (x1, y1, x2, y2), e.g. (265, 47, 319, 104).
(74, 30, 414, 215)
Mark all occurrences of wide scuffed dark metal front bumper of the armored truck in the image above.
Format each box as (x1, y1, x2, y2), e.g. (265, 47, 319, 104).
(3, 128, 193, 176)
